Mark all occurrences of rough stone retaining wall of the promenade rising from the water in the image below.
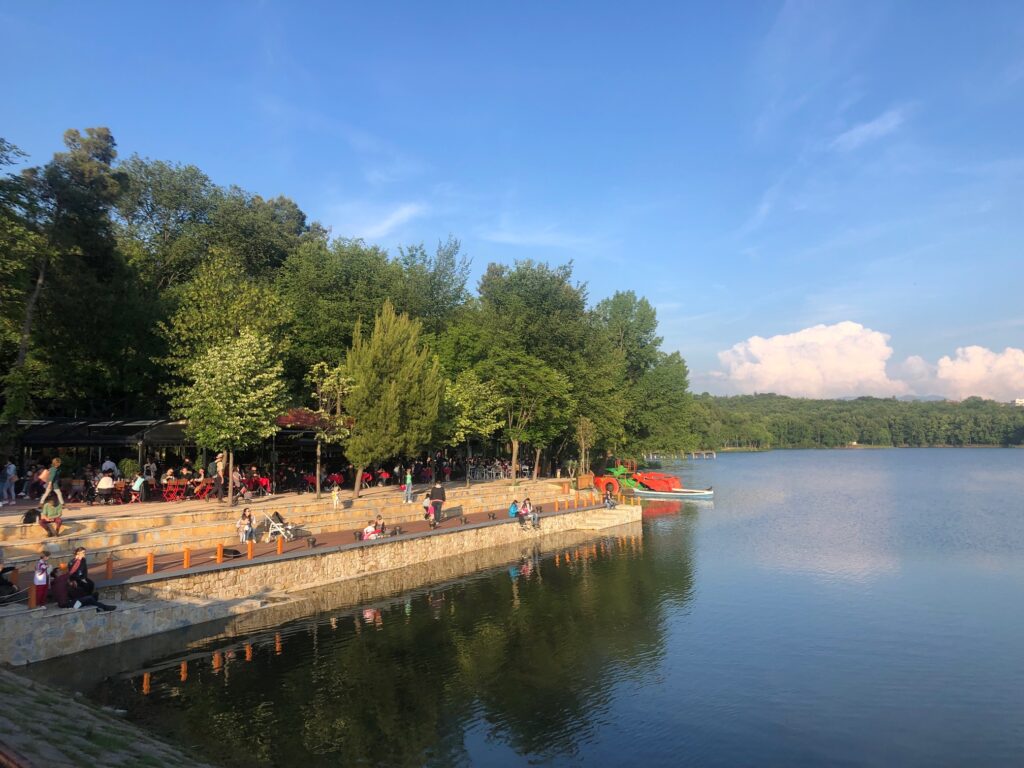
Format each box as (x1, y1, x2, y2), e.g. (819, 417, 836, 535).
(0, 506, 641, 666)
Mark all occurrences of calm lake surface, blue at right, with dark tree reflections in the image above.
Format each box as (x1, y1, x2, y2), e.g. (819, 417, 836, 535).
(28, 450, 1024, 766)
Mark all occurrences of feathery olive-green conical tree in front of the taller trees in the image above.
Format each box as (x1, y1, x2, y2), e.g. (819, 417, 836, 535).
(344, 301, 444, 498)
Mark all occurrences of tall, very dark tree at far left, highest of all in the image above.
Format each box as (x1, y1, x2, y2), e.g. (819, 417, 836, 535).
(5, 128, 136, 420)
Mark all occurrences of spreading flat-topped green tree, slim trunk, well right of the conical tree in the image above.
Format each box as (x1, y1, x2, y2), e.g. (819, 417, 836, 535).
(476, 349, 572, 482)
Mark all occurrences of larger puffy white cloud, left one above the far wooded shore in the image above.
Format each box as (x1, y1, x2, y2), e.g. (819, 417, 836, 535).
(718, 321, 909, 397)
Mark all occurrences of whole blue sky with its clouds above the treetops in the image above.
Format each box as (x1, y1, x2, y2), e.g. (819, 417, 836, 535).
(0, 1, 1024, 398)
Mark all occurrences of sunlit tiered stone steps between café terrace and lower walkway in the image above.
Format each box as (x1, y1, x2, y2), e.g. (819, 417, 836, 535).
(0, 480, 595, 565)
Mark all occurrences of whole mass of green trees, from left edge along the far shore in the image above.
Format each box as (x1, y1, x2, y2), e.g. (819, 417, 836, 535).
(16, 127, 1024, 475)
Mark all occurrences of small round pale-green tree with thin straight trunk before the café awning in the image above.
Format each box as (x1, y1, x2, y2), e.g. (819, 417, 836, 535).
(174, 328, 286, 504)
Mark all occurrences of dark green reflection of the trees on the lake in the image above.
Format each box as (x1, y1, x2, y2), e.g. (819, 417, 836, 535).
(70, 526, 691, 766)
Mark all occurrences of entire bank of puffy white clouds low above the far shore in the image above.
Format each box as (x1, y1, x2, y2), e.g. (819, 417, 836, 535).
(712, 321, 1024, 402)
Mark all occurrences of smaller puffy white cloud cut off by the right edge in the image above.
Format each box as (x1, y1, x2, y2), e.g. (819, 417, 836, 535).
(935, 346, 1024, 400)
